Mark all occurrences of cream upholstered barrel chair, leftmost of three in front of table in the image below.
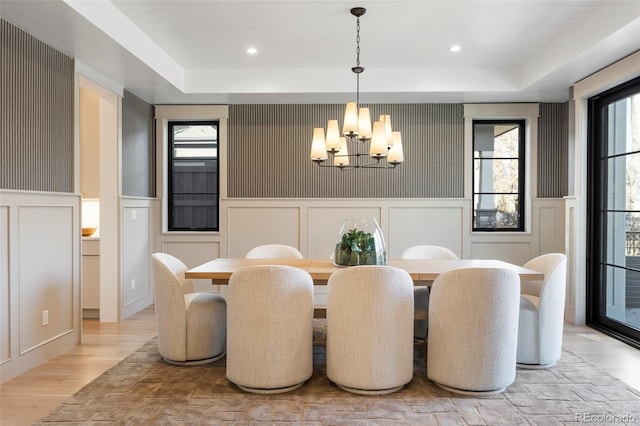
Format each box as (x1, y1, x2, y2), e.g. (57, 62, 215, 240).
(227, 265, 313, 394)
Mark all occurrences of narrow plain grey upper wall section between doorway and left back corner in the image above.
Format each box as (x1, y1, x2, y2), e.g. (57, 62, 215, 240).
(122, 91, 155, 197)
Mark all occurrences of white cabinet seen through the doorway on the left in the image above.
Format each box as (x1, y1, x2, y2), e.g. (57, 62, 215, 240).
(81, 238, 100, 318)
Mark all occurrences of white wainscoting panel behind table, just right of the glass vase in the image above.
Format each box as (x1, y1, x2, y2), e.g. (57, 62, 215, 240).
(387, 206, 463, 258)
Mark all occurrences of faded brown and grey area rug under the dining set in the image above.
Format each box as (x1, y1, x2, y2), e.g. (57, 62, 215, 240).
(35, 332, 640, 425)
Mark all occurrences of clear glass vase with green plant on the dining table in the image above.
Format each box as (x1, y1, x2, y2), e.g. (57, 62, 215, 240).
(333, 218, 387, 266)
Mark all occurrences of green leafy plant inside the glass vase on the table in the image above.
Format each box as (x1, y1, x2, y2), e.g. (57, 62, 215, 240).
(335, 228, 386, 266)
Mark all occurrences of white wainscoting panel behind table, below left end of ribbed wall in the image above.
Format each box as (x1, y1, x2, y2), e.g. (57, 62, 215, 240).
(227, 206, 300, 257)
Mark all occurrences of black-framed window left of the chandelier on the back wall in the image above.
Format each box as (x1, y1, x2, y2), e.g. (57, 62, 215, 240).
(167, 121, 219, 231)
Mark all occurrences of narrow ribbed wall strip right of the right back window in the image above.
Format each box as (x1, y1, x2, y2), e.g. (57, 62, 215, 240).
(538, 102, 569, 198)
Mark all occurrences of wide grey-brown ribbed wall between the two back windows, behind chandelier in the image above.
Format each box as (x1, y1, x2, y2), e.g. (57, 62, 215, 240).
(228, 104, 464, 198)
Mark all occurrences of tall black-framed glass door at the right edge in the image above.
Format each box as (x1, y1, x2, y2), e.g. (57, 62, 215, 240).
(587, 75, 640, 347)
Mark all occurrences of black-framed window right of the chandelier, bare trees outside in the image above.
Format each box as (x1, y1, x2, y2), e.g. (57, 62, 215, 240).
(473, 119, 525, 231)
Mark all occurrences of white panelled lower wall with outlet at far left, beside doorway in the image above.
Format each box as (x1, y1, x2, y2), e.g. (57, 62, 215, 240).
(0, 190, 81, 383)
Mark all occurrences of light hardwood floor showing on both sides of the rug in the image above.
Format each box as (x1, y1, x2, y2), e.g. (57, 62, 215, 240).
(0, 308, 640, 425)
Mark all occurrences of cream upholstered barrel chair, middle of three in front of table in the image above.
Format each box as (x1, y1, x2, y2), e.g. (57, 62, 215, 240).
(326, 266, 413, 394)
